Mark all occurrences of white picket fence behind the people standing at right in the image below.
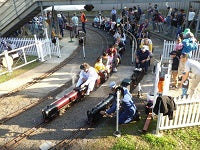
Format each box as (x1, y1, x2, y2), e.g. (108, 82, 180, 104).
(162, 40, 200, 62)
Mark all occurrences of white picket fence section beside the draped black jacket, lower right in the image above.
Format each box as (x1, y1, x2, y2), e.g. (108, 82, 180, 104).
(156, 97, 200, 133)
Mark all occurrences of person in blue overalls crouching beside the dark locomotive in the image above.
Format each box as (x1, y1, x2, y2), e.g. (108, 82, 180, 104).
(100, 81, 140, 124)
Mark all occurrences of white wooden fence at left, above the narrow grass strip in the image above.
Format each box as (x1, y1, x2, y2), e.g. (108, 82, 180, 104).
(0, 35, 61, 75)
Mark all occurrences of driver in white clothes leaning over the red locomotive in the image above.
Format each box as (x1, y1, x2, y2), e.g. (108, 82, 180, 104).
(76, 63, 98, 95)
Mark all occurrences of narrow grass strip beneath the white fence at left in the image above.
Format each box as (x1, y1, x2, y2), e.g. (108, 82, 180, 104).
(0, 56, 41, 83)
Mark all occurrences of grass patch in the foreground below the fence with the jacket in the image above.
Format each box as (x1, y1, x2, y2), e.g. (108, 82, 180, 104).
(83, 113, 200, 150)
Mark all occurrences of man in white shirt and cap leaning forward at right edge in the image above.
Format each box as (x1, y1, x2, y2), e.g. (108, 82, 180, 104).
(180, 54, 200, 98)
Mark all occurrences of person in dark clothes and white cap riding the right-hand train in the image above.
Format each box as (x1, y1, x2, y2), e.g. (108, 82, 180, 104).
(135, 45, 150, 74)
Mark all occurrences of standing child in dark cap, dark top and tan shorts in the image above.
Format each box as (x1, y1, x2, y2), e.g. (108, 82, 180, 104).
(169, 51, 179, 88)
